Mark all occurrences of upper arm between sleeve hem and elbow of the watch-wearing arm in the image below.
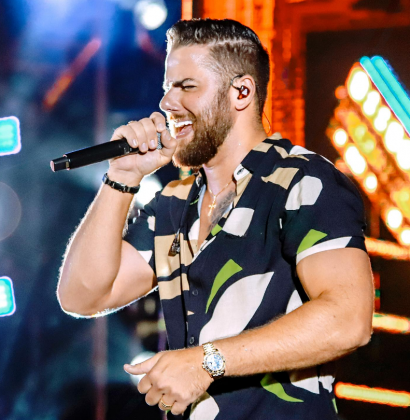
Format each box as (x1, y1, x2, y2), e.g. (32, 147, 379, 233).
(296, 248, 374, 317)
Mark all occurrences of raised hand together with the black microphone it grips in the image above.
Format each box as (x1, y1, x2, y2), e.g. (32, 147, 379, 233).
(50, 112, 177, 182)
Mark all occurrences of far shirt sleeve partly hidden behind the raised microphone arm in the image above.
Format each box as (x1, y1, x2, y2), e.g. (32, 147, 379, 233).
(123, 192, 160, 272)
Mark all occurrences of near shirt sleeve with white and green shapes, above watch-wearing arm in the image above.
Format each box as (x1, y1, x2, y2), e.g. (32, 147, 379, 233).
(280, 155, 366, 264)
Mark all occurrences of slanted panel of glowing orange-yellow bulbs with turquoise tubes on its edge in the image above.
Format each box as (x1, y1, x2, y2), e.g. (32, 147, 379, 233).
(326, 56, 410, 246)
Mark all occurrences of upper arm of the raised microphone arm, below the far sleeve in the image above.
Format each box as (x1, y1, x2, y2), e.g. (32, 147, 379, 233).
(99, 240, 157, 309)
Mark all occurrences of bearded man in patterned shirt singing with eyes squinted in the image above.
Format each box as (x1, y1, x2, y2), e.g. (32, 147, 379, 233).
(58, 20, 373, 420)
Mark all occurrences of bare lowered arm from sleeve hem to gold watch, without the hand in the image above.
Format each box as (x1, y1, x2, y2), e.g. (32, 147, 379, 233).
(215, 248, 374, 375)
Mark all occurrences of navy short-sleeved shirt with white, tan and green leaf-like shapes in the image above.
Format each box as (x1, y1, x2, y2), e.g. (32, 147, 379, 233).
(125, 138, 365, 420)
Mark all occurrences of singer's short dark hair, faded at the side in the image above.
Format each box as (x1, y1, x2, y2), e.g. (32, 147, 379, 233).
(167, 18, 270, 116)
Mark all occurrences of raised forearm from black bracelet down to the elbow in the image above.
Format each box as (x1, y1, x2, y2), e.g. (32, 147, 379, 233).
(58, 180, 139, 310)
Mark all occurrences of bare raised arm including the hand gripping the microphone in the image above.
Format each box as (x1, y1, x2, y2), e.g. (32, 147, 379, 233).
(57, 113, 176, 315)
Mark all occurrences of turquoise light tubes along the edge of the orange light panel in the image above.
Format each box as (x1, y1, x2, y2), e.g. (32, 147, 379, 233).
(360, 56, 410, 134)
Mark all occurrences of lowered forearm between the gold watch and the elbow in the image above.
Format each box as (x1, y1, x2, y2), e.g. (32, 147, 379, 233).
(214, 298, 371, 376)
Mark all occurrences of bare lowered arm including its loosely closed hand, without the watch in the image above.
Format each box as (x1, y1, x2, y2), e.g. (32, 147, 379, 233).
(125, 248, 374, 414)
